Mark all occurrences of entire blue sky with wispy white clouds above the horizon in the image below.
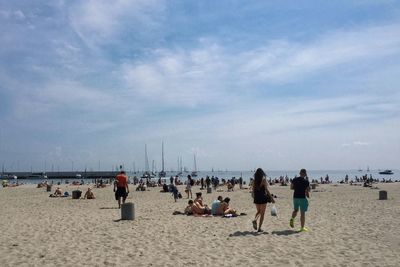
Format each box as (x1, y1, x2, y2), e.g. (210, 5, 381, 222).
(0, 0, 400, 173)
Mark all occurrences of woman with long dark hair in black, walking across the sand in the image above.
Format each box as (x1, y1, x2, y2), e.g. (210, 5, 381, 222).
(253, 168, 275, 232)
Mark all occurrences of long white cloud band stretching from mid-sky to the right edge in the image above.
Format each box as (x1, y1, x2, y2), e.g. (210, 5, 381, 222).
(121, 24, 400, 106)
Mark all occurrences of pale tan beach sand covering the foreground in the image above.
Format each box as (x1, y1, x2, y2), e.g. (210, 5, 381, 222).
(0, 183, 400, 266)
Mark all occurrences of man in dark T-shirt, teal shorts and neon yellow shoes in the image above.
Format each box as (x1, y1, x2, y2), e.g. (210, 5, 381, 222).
(289, 169, 310, 232)
